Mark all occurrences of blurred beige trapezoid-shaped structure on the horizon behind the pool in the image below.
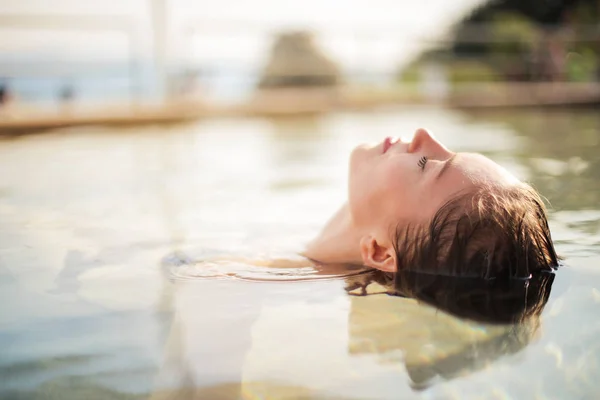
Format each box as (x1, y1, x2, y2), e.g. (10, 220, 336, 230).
(258, 32, 340, 89)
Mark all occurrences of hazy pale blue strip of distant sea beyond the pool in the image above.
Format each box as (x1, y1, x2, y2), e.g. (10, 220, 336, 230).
(0, 64, 260, 106)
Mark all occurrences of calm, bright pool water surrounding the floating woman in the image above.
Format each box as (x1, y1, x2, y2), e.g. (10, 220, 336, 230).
(0, 108, 600, 400)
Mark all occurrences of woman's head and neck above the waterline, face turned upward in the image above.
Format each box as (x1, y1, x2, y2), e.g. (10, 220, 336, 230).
(304, 129, 558, 279)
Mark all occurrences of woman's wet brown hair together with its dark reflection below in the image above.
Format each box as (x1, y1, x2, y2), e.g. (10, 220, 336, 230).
(370, 184, 558, 323)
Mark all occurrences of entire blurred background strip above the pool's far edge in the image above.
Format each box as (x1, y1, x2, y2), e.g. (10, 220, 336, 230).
(0, 0, 600, 130)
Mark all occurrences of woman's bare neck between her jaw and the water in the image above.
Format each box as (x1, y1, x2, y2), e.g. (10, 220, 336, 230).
(304, 204, 362, 264)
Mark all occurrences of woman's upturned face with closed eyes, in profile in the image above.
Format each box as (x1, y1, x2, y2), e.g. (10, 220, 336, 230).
(349, 129, 518, 231)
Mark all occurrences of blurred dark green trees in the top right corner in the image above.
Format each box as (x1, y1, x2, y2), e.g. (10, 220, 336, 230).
(449, 0, 600, 80)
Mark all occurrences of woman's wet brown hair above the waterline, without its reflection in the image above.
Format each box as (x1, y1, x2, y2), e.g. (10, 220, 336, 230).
(394, 184, 558, 282)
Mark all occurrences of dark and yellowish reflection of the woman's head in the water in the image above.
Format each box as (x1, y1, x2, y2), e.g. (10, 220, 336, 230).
(346, 272, 554, 389)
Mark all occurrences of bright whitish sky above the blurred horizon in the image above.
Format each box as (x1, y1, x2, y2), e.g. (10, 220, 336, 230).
(0, 0, 481, 73)
